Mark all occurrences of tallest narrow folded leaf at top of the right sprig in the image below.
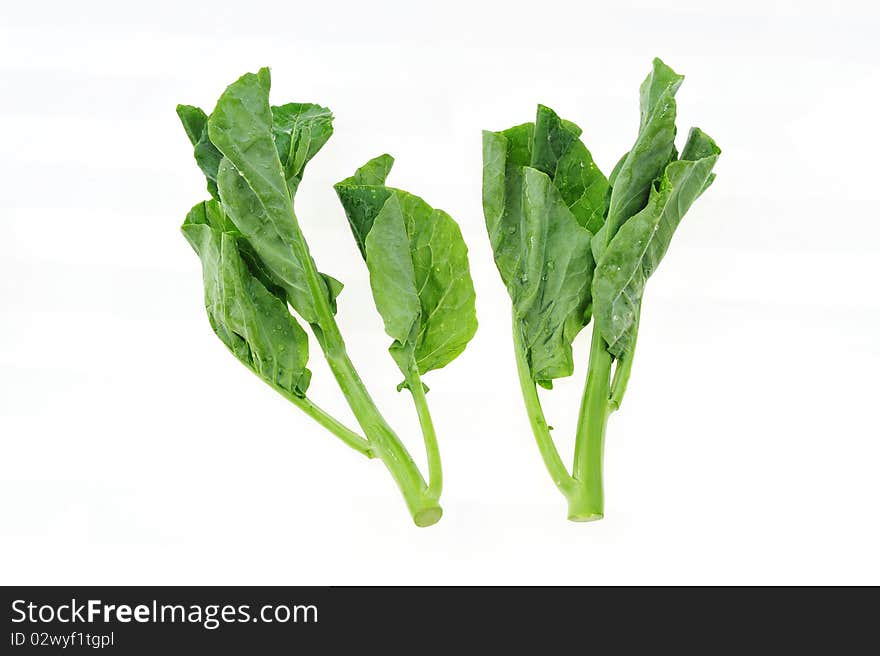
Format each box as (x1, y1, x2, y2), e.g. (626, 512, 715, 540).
(596, 59, 684, 249)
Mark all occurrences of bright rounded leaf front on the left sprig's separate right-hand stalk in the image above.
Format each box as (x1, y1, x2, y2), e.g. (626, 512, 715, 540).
(365, 189, 477, 374)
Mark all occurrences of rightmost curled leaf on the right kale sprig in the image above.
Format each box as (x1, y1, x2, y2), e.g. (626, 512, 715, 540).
(593, 129, 721, 358)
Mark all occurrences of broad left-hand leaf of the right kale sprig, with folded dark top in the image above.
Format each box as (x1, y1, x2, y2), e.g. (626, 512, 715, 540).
(483, 105, 608, 387)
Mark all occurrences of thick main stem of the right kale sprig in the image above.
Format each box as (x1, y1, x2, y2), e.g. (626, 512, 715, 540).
(568, 326, 612, 522)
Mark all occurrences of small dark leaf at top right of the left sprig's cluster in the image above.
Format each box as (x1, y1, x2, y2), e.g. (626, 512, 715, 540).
(272, 103, 333, 196)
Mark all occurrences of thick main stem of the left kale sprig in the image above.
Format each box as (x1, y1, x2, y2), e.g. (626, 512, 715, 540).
(292, 210, 443, 526)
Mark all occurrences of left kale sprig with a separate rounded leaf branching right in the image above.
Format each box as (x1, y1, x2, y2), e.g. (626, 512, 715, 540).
(177, 68, 477, 526)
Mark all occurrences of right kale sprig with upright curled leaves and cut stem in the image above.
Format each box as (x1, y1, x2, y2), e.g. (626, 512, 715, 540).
(483, 59, 721, 521)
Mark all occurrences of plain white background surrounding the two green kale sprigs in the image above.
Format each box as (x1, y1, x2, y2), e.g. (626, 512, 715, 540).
(0, 0, 880, 584)
